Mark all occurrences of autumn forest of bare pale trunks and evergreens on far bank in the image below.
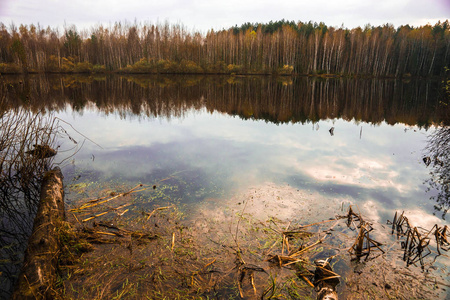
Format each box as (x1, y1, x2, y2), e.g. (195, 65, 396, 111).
(0, 20, 450, 77)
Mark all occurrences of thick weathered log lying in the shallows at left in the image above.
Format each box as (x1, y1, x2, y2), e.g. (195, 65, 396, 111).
(11, 168, 65, 300)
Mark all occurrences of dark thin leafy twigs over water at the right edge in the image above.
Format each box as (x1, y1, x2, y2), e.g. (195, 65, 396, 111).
(423, 126, 450, 219)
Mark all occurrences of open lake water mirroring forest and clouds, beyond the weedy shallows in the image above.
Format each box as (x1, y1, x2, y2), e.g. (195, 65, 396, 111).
(0, 76, 449, 298)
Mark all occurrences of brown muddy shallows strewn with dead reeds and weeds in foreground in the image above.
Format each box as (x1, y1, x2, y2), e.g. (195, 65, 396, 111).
(58, 183, 449, 299)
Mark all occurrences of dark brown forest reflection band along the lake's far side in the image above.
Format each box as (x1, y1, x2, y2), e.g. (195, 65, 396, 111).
(0, 75, 442, 128)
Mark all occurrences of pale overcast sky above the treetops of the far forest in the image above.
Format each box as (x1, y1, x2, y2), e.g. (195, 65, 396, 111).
(0, 0, 450, 33)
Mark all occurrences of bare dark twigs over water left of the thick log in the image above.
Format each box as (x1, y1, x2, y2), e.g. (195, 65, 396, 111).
(0, 105, 55, 299)
